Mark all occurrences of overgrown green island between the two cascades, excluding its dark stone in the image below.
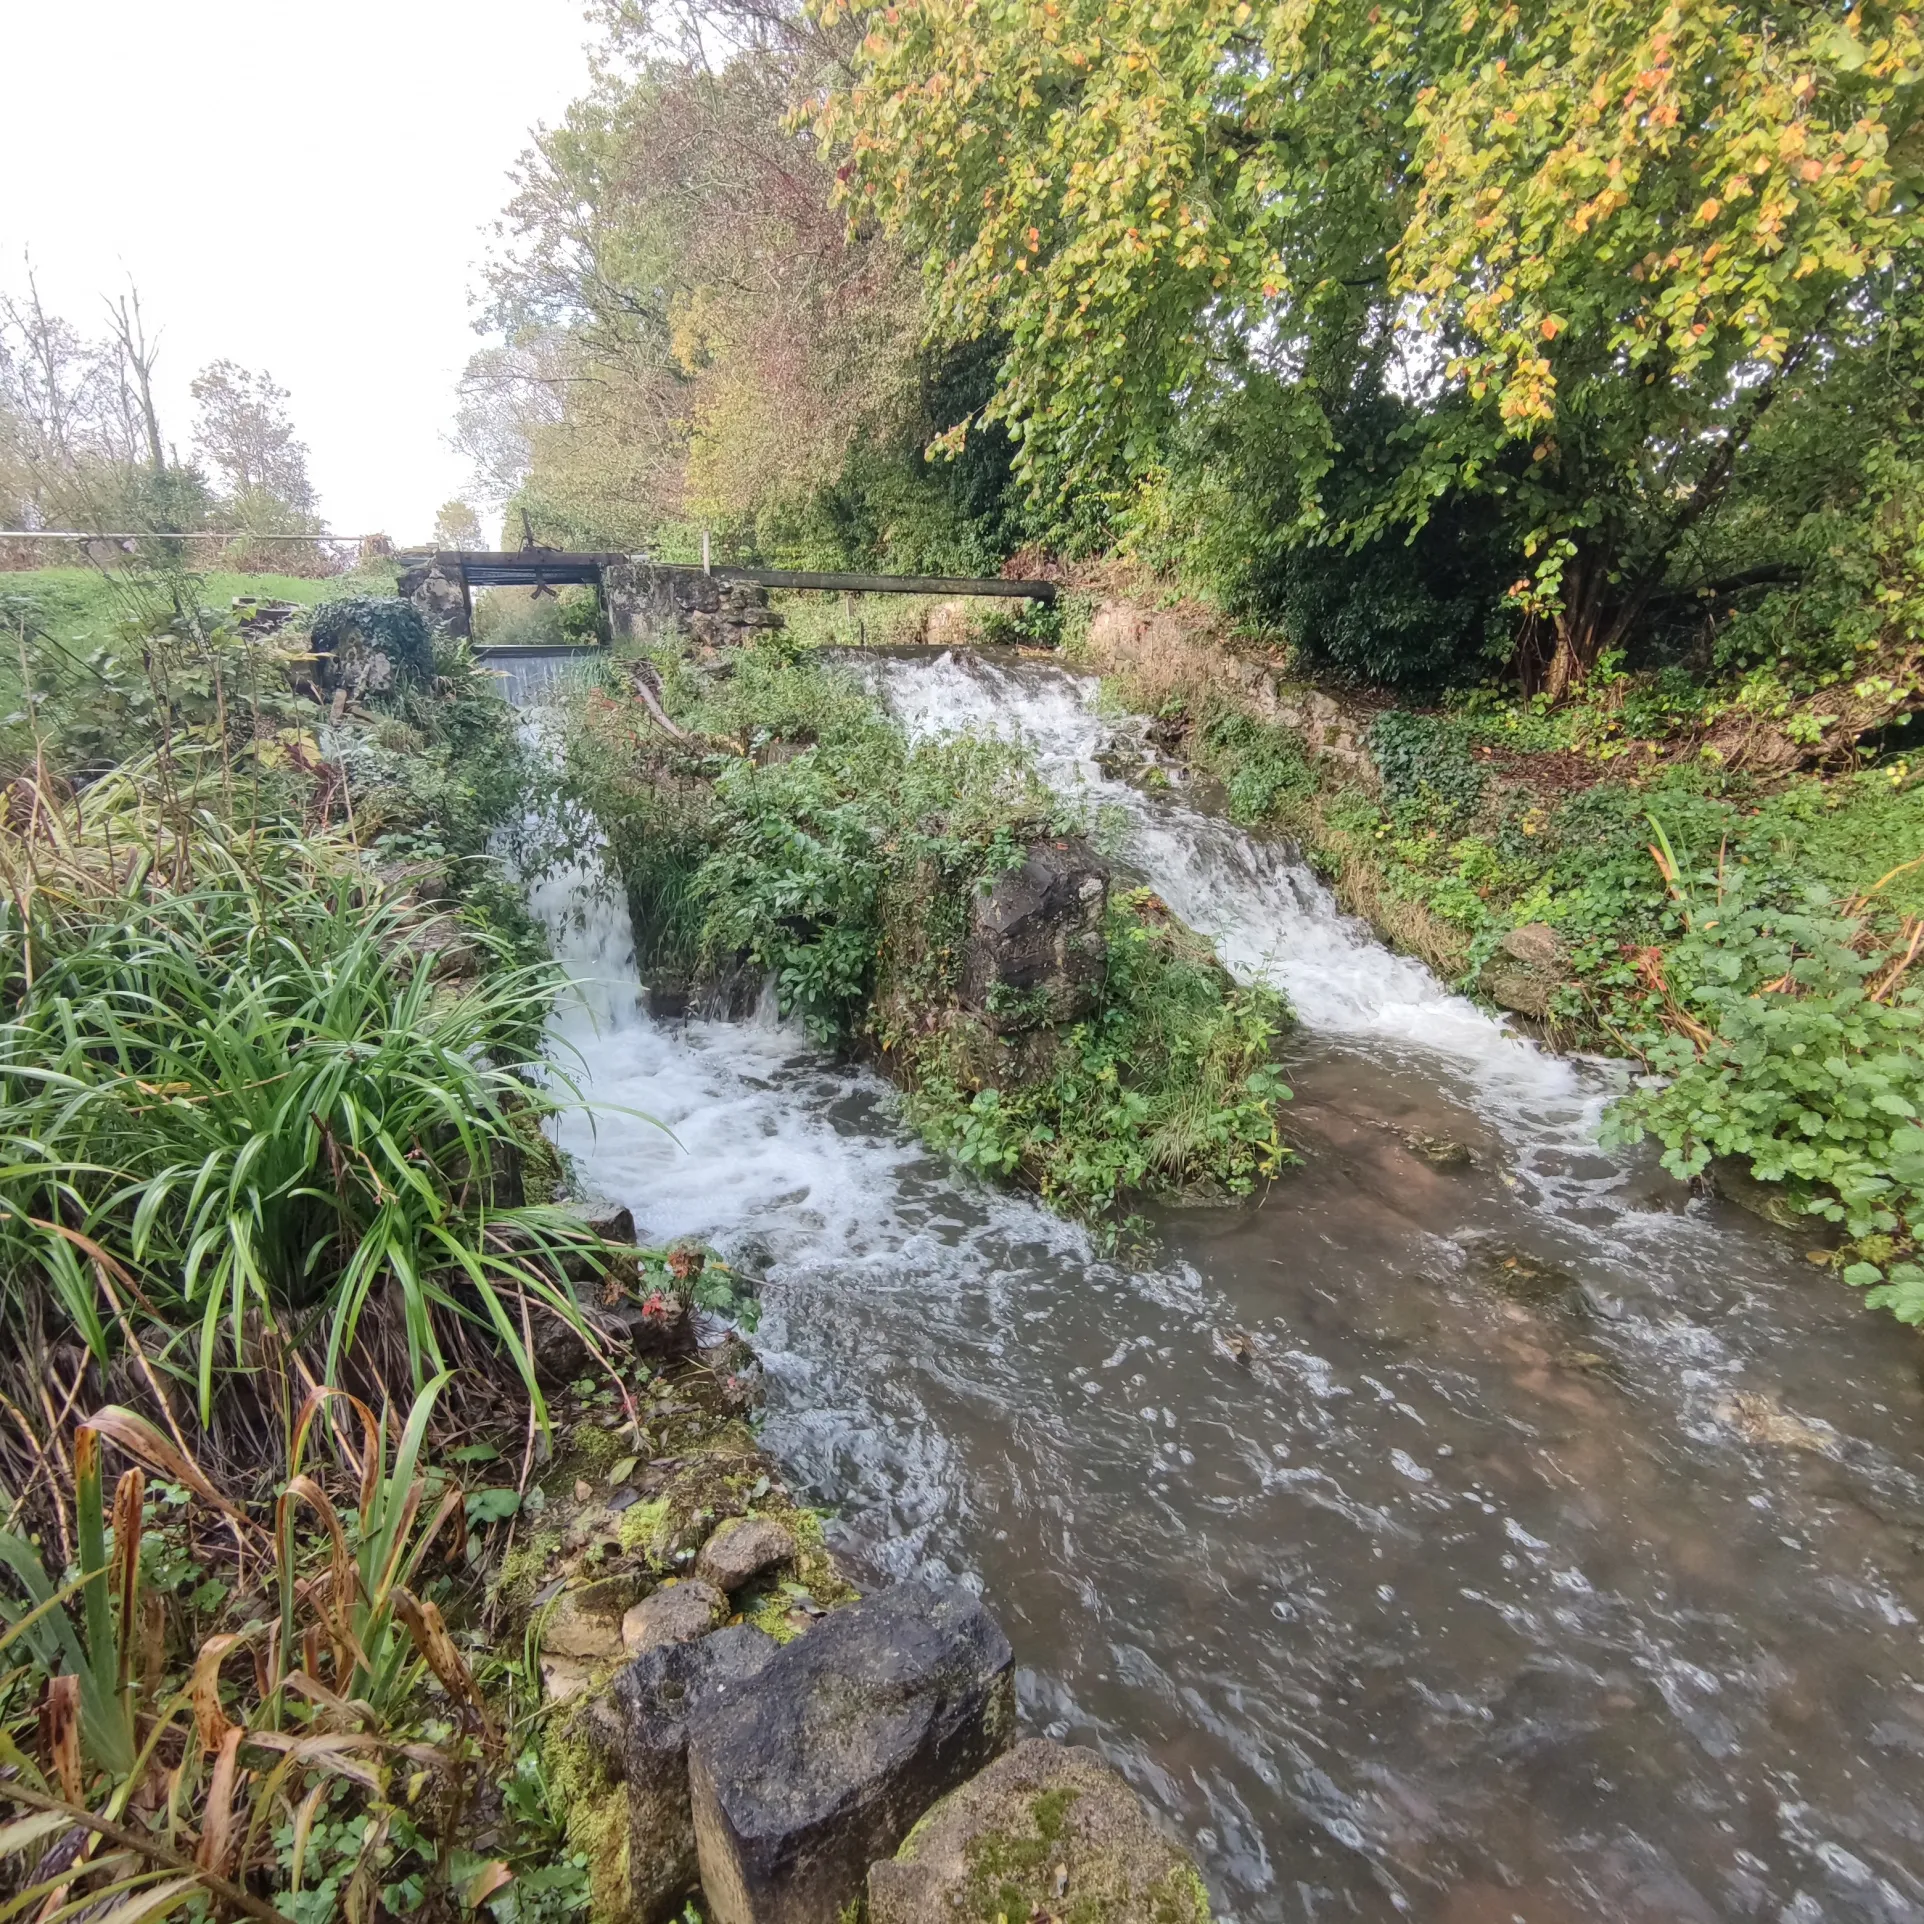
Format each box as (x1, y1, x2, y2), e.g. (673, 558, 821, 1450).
(568, 637, 1289, 1216)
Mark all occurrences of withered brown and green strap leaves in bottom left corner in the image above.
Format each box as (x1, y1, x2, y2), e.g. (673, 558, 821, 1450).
(0, 1400, 587, 1924)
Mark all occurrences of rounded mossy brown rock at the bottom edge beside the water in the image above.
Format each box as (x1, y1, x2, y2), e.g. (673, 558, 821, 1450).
(868, 1737, 1210, 1924)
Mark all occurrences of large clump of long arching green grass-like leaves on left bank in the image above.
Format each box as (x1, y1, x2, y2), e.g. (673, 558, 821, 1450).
(0, 804, 600, 1422)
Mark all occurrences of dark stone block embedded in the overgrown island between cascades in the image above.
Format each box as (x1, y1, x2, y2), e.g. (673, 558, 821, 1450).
(962, 841, 1108, 1033)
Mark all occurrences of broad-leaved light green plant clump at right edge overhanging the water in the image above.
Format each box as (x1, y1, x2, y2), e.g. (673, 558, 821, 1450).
(1608, 822, 1924, 1324)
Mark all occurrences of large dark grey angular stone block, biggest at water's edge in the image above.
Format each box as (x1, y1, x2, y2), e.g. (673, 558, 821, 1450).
(689, 1583, 1016, 1924)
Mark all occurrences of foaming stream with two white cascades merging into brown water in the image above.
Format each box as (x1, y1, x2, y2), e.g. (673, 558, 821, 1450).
(535, 656, 1924, 1924)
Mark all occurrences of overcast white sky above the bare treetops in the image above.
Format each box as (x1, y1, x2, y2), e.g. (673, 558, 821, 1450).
(0, 0, 589, 543)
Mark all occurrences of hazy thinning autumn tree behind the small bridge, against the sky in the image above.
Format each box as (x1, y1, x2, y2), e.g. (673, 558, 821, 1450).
(460, 10, 920, 546)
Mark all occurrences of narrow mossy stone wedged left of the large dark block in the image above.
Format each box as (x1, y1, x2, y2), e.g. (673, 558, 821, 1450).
(608, 1624, 777, 1924)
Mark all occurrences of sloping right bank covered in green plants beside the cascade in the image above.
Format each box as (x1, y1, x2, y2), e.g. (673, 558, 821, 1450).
(1108, 600, 1924, 1322)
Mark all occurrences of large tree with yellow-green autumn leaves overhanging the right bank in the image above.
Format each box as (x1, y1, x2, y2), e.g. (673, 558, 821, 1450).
(818, 0, 1924, 691)
